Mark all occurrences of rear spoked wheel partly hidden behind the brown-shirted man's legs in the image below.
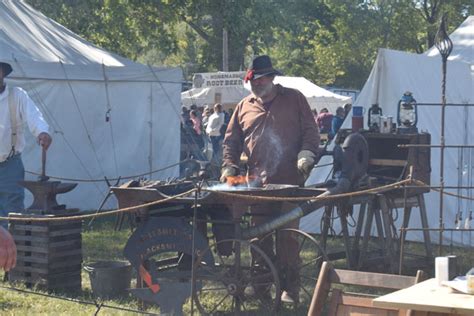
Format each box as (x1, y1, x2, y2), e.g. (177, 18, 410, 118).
(259, 228, 328, 304)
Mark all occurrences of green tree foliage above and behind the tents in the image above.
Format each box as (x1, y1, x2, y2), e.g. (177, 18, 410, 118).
(28, 0, 474, 88)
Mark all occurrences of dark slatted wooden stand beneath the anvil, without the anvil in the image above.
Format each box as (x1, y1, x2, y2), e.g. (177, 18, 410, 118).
(9, 213, 82, 291)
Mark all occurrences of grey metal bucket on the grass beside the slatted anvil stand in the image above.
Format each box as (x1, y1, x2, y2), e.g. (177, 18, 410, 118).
(84, 261, 132, 298)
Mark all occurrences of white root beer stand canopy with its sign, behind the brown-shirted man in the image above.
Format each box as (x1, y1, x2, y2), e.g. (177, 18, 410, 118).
(181, 71, 351, 113)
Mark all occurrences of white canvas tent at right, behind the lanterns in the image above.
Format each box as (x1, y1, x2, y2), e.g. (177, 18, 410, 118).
(301, 43, 474, 246)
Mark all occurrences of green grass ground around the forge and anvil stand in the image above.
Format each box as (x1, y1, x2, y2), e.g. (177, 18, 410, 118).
(0, 218, 474, 316)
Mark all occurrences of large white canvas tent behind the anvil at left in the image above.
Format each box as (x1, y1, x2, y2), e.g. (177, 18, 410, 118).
(0, 1, 182, 209)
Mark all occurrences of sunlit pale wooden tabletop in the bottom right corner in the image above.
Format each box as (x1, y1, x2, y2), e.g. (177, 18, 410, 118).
(373, 279, 474, 315)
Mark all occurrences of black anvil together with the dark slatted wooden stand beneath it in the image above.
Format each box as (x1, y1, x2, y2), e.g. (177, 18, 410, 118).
(8, 179, 82, 293)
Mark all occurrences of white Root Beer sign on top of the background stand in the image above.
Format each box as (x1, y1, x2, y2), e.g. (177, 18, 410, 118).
(193, 71, 245, 88)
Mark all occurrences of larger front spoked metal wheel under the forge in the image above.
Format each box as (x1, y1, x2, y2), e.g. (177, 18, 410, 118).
(193, 239, 281, 315)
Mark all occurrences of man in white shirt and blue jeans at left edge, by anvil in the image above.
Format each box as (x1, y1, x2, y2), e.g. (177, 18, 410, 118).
(0, 62, 52, 227)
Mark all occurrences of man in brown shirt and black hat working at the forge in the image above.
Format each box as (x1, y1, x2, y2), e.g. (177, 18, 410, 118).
(220, 55, 320, 303)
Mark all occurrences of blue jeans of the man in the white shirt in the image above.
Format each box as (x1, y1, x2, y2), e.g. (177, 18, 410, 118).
(0, 154, 25, 228)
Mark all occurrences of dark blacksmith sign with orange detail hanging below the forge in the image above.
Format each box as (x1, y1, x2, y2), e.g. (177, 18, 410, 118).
(124, 217, 214, 315)
